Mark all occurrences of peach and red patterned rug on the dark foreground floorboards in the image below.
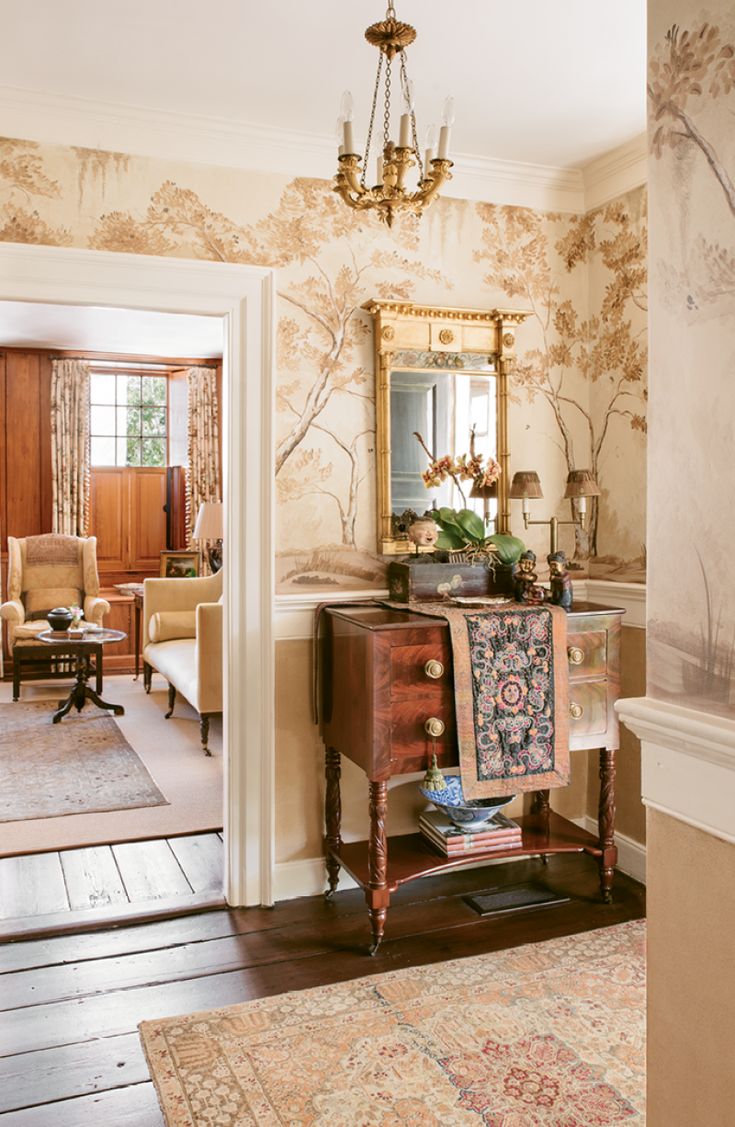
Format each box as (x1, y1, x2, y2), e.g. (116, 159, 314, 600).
(140, 921, 645, 1127)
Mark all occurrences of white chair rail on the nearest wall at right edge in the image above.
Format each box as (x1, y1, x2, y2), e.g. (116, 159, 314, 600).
(616, 696, 735, 843)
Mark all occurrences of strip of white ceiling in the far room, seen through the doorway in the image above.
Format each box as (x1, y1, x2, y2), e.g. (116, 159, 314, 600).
(0, 301, 222, 360)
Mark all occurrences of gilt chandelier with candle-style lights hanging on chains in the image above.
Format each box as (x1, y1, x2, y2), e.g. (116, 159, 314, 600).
(334, 2, 454, 227)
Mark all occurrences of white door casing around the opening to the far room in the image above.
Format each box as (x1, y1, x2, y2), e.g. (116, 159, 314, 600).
(0, 243, 275, 905)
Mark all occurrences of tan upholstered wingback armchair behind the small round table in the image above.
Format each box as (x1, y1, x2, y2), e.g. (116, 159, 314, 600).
(0, 533, 109, 653)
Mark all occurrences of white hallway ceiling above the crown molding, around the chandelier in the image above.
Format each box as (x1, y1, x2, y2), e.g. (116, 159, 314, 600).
(0, 0, 646, 166)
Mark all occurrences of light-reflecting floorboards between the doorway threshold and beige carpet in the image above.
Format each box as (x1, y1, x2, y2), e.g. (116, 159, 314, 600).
(0, 833, 224, 942)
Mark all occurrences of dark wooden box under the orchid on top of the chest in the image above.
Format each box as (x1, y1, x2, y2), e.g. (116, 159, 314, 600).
(388, 556, 514, 603)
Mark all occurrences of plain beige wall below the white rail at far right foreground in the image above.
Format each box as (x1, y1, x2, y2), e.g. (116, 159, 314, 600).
(647, 810, 735, 1127)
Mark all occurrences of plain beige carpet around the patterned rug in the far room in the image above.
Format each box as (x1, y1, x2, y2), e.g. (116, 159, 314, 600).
(0, 675, 222, 857)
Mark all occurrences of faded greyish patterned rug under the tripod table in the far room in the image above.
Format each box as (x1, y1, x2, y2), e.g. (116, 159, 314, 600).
(0, 700, 168, 822)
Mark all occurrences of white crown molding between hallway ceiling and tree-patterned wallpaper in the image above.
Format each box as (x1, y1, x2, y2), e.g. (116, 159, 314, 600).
(0, 86, 645, 212)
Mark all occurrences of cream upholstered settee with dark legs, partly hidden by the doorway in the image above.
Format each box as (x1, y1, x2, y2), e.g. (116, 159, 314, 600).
(142, 571, 222, 755)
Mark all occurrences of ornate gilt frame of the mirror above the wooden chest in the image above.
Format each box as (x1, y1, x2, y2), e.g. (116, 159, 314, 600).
(362, 301, 530, 556)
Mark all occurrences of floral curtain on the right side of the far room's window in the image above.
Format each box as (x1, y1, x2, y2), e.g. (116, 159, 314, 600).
(186, 367, 222, 550)
